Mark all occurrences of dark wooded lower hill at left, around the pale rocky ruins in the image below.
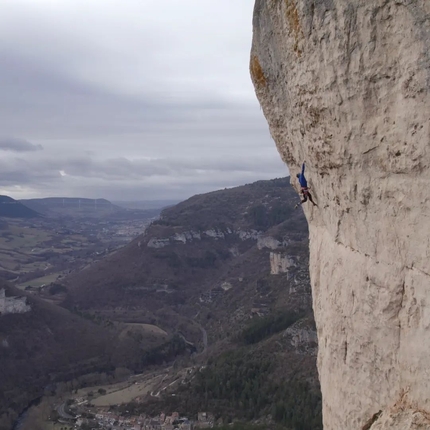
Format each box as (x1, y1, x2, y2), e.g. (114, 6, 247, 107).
(0, 281, 166, 430)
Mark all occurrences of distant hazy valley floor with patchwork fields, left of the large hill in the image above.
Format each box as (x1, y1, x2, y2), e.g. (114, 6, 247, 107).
(0, 200, 160, 292)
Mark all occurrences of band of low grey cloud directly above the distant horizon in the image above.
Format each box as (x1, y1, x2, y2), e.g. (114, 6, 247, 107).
(0, 153, 286, 199)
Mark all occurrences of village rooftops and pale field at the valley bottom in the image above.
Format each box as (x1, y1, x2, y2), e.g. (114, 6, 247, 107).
(49, 368, 215, 430)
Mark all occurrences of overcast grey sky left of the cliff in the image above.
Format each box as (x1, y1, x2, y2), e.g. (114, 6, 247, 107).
(0, 0, 288, 200)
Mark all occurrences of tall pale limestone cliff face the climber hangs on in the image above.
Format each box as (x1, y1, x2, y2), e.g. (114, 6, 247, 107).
(250, 0, 430, 430)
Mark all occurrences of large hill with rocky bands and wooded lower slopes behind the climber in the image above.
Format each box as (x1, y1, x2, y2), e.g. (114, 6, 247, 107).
(63, 178, 321, 429)
